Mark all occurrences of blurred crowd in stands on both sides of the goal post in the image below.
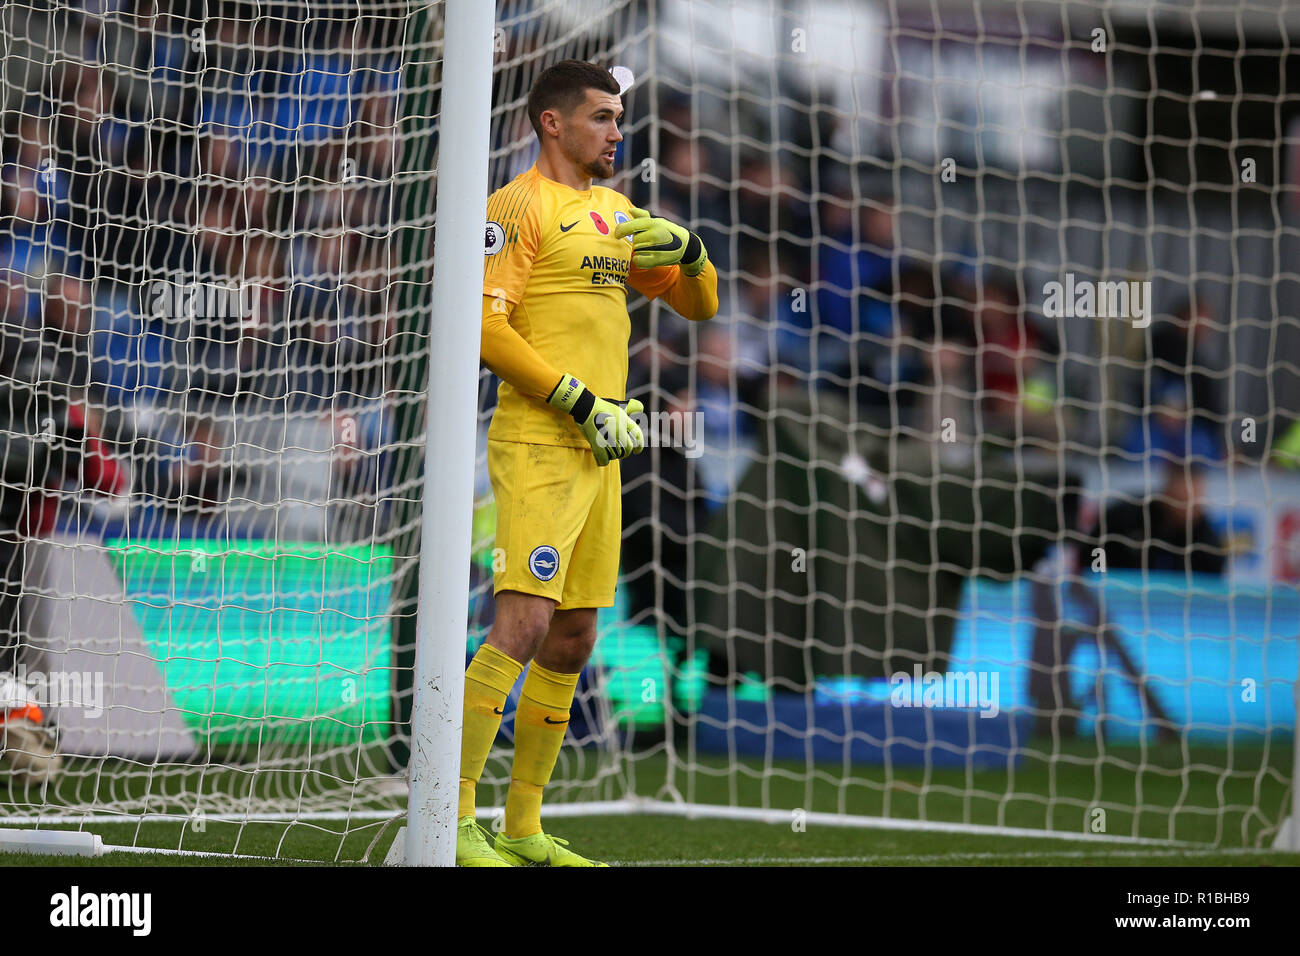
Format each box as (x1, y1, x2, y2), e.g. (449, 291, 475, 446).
(0, 0, 1279, 574)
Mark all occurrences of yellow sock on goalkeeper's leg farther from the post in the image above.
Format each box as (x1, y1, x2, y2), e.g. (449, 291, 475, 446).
(504, 661, 579, 840)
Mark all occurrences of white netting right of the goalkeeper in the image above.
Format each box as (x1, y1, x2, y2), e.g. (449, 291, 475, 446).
(493, 0, 1300, 845)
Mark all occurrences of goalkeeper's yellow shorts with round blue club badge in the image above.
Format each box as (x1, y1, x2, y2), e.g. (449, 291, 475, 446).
(488, 440, 623, 610)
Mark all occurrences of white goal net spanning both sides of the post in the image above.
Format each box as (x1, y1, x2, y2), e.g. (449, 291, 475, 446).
(0, 0, 1300, 861)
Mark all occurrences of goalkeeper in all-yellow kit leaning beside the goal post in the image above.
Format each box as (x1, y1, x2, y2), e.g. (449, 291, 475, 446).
(456, 60, 718, 866)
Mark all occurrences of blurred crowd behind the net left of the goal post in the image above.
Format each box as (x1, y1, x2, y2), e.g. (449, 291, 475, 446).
(0, 0, 399, 535)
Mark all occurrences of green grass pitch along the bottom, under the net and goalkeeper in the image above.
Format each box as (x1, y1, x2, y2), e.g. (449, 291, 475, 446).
(0, 740, 1300, 866)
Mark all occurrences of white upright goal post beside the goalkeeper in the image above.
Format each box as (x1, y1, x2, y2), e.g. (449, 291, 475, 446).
(404, 0, 495, 866)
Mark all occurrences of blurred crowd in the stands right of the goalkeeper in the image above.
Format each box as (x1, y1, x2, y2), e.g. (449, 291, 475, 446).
(618, 89, 1258, 507)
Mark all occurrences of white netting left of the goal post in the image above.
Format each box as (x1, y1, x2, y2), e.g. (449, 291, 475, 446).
(0, 3, 442, 852)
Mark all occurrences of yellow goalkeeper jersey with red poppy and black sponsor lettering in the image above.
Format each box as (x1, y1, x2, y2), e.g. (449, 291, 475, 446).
(484, 165, 716, 447)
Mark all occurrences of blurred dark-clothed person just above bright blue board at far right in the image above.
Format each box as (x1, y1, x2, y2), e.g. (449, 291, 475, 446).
(1091, 460, 1226, 575)
